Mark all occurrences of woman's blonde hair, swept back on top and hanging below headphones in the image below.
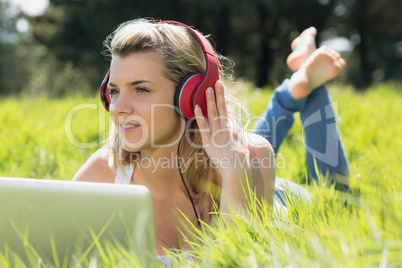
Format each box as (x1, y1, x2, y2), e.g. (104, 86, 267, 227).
(104, 19, 242, 222)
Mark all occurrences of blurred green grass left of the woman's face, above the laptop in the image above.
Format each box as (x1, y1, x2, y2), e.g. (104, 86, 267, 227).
(0, 97, 108, 180)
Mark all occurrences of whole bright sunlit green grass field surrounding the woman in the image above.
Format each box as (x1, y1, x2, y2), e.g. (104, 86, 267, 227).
(0, 84, 402, 267)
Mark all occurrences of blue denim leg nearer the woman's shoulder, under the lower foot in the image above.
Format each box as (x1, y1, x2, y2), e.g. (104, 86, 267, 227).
(251, 79, 306, 154)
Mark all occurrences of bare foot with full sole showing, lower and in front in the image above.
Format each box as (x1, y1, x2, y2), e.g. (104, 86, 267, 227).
(289, 46, 346, 99)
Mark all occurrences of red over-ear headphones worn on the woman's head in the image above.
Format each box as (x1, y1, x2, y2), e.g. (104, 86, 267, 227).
(100, 21, 219, 119)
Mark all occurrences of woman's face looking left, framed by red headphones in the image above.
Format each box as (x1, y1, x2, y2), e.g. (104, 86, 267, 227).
(109, 52, 181, 152)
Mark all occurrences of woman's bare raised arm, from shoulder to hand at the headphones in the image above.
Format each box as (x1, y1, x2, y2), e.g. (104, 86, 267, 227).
(195, 81, 275, 216)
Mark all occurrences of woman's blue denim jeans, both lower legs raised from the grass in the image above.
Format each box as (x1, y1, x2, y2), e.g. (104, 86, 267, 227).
(252, 80, 349, 205)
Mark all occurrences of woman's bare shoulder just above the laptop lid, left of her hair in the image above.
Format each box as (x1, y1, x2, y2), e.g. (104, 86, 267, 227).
(73, 147, 116, 183)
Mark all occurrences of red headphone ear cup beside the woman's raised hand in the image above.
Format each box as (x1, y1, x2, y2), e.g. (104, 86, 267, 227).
(174, 73, 206, 119)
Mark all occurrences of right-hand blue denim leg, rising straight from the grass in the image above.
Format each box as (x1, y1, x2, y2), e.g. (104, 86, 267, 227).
(300, 85, 349, 190)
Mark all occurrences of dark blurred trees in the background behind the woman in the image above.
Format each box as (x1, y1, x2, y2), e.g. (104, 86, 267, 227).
(0, 0, 402, 95)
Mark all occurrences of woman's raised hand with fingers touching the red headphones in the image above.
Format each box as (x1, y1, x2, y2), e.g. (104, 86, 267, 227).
(194, 80, 249, 180)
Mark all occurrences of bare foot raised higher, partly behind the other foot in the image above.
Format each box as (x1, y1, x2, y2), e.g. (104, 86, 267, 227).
(286, 27, 317, 71)
